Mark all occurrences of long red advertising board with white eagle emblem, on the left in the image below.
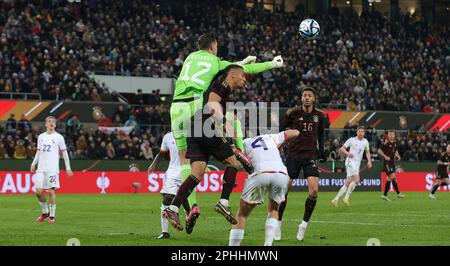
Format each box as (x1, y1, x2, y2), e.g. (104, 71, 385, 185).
(0, 171, 246, 194)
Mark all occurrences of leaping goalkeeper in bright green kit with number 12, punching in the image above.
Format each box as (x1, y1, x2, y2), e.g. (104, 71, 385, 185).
(170, 33, 284, 233)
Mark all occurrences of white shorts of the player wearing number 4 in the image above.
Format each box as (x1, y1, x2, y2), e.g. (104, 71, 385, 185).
(241, 173, 290, 205)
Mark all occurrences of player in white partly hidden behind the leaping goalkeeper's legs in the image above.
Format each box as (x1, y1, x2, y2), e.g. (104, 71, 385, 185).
(147, 132, 194, 239)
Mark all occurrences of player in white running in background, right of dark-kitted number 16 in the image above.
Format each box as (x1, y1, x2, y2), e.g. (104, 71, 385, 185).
(331, 126, 372, 207)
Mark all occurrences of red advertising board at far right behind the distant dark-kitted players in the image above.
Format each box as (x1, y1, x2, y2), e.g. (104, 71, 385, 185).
(381, 172, 450, 191)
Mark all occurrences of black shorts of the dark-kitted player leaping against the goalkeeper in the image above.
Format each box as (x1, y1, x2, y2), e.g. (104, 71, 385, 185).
(186, 137, 234, 163)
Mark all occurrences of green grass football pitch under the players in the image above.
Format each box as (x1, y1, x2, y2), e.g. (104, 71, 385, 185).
(0, 192, 450, 246)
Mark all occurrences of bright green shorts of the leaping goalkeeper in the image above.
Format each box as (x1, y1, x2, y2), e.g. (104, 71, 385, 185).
(170, 97, 203, 150)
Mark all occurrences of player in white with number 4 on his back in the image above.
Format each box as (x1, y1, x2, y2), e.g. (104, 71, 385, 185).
(228, 130, 299, 246)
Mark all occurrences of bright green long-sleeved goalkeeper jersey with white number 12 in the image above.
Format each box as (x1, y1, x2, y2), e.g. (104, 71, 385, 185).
(173, 50, 272, 100)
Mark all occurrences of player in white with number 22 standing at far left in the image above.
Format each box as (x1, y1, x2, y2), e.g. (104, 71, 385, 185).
(30, 116, 73, 223)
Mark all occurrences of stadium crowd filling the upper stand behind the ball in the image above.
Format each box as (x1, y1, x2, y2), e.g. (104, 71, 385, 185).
(0, 0, 450, 112)
